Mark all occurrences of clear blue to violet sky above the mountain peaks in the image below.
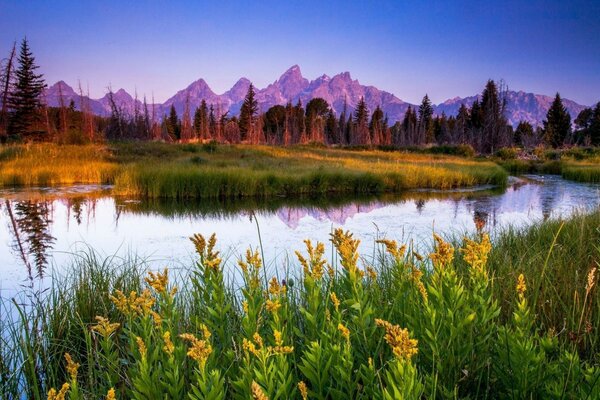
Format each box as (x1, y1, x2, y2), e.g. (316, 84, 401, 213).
(0, 0, 600, 105)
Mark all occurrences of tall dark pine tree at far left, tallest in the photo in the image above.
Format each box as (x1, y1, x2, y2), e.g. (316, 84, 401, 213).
(8, 38, 46, 138)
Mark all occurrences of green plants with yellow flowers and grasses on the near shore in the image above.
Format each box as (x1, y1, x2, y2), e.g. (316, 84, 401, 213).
(0, 213, 600, 399)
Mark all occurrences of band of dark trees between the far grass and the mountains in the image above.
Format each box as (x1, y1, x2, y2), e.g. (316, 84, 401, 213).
(0, 39, 600, 154)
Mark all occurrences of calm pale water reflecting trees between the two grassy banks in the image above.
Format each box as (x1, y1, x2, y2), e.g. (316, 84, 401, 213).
(0, 176, 600, 297)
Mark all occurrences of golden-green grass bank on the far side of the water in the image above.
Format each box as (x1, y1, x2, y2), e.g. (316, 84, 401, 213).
(0, 143, 507, 199)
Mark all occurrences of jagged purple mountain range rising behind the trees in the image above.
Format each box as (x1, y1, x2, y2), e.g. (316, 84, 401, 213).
(46, 65, 586, 125)
